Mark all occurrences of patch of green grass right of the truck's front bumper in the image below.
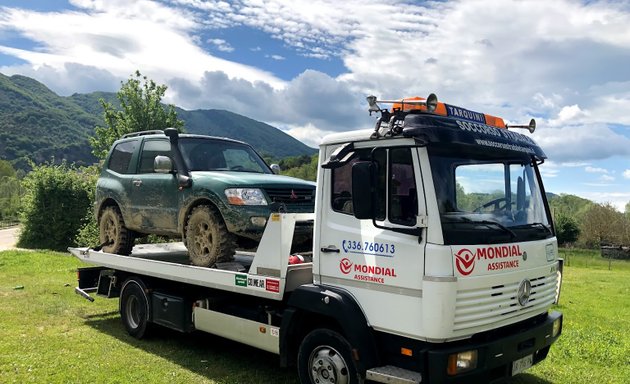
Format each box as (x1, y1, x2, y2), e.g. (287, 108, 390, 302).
(513, 249, 630, 384)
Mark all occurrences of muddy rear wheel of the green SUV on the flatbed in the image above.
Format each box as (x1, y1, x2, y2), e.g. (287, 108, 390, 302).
(98, 206, 134, 255)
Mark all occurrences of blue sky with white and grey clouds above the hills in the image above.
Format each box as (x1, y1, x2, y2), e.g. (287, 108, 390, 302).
(0, 0, 630, 210)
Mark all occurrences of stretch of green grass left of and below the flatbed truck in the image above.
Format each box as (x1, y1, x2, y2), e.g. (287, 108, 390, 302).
(0, 251, 297, 384)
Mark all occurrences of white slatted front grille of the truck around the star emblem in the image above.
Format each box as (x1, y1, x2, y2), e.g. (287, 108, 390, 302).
(453, 273, 558, 331)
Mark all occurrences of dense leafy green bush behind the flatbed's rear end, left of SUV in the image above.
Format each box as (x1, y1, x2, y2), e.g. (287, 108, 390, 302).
(17, 162, 97, 251)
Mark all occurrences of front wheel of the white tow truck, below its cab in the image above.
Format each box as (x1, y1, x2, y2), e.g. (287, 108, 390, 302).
(298, 328, 364, 384)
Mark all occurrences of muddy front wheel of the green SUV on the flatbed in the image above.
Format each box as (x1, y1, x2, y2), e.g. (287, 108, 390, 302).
(186, 205, 235, 267)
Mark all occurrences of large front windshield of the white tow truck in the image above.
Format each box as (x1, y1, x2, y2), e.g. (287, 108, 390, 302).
(430, 151, 553, 245)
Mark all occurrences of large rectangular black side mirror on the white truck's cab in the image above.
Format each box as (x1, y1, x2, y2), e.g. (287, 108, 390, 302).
(352, 161, 376, 220)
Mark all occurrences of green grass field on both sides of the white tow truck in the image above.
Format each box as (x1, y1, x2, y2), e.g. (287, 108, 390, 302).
(0, 250, 630, 384)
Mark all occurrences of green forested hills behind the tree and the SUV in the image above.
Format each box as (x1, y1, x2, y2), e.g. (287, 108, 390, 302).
(0, 74, 316, 169)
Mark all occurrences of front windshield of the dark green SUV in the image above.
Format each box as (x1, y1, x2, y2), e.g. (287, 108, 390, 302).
(179, 137, 273, 173)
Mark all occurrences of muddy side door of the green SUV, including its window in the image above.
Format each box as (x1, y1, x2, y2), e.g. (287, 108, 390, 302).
(130, 138, 179, 235)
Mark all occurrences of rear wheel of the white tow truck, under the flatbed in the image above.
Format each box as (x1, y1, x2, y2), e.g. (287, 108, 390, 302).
(120, 278, 151, 339)
